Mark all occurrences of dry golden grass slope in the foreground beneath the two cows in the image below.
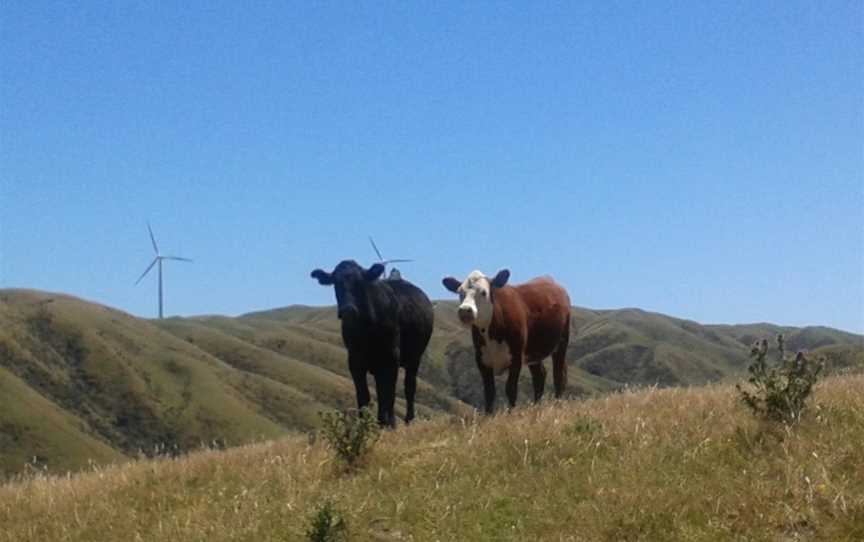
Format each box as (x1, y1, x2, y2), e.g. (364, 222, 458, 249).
(0, 376, 864, 542)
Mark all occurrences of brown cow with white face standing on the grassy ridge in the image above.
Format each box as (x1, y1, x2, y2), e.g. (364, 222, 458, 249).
(442, 269, 570, 413)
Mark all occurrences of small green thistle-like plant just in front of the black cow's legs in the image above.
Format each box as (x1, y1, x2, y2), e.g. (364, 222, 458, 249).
(320, 408, 381, 468)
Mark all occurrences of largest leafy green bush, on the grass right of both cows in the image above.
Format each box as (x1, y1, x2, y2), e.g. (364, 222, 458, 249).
(736, 334, 824, 424)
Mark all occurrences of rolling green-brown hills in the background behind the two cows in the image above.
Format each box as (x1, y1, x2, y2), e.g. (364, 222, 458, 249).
(0, 290, 864, 477)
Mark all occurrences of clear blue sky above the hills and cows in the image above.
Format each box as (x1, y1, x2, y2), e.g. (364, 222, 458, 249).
(0, 0, 864, 332)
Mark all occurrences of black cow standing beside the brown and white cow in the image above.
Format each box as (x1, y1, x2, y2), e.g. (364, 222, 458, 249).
(312, 260, 434, 426)
